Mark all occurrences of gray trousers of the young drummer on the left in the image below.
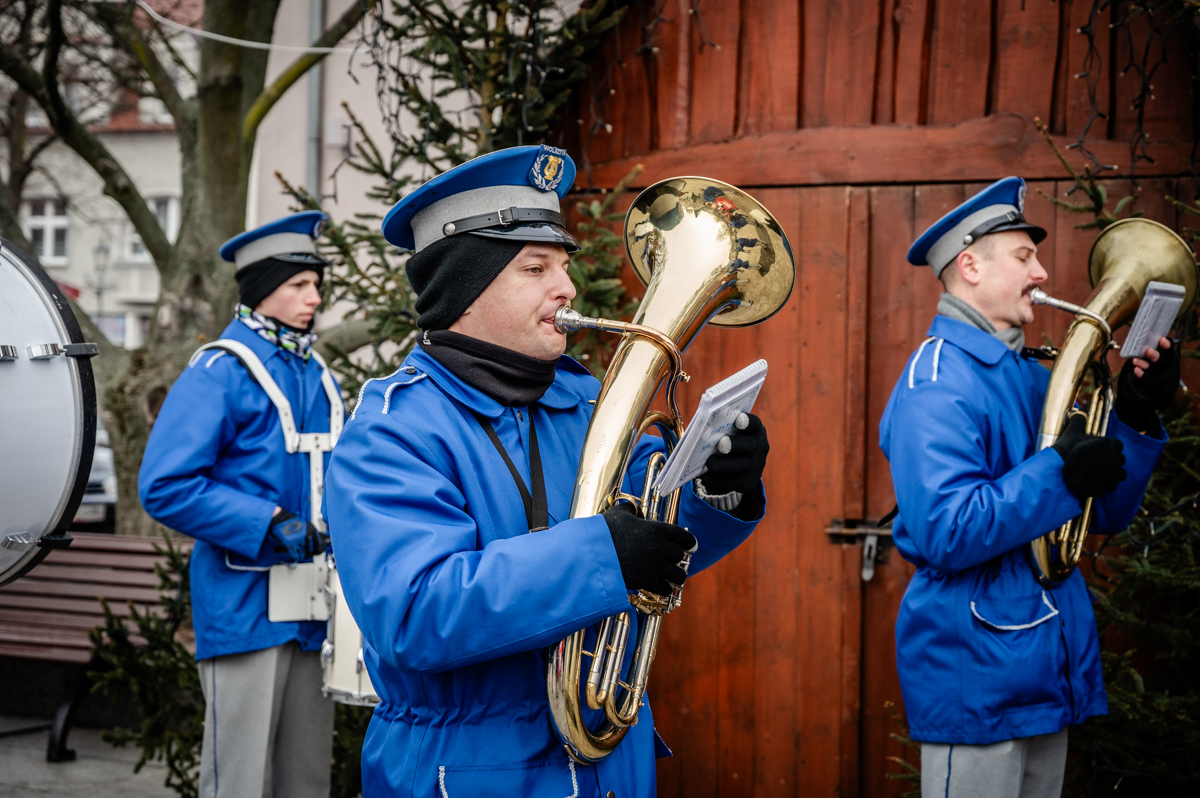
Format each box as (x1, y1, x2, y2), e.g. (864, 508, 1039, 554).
(199, 642, 334, 798)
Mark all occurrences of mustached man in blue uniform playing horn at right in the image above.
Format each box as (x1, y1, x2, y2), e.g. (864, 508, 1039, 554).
(880, 178, 1180, 798)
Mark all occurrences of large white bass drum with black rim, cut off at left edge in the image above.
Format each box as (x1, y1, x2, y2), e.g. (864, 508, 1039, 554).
(0, 239, 98, 586)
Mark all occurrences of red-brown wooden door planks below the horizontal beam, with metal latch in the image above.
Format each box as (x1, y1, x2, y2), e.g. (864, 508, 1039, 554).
(578, 180, 1177, 798)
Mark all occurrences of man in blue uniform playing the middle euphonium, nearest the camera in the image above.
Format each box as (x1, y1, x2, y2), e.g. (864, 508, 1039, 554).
(326, 146, 768, 798)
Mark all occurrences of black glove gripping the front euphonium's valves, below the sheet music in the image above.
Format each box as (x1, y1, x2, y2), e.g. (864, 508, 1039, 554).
(604, 503, 696, 595)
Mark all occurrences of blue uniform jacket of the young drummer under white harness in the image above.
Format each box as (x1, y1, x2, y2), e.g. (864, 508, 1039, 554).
(138, 319, 340, 660)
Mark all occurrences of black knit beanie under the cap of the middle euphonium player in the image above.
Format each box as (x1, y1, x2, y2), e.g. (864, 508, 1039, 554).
(404, 234, 526, 330)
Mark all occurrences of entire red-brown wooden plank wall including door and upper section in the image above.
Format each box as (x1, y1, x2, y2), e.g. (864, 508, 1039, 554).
(558, 0, 1200, 798)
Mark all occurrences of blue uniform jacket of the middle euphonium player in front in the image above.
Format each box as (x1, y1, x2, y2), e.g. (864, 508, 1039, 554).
(325, 348, 762, 798)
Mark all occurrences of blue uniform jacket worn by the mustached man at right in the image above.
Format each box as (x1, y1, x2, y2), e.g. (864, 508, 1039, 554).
(880, 316, 1166, 744)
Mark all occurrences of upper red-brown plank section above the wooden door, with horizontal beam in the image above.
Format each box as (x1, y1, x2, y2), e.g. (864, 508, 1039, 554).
(562, 0, 1193, 186)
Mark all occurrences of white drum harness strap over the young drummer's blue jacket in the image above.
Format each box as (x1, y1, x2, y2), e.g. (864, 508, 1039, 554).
(188, 338, 346, 542)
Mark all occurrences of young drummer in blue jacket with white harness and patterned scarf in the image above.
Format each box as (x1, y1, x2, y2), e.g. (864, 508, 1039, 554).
(138, 211, 344, 798)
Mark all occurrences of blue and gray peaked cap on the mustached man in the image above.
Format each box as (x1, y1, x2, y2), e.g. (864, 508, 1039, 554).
(908, 178, 1046, 278)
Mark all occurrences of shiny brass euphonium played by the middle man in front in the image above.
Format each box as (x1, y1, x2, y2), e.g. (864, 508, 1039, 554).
(546, 178, 796, 764)
